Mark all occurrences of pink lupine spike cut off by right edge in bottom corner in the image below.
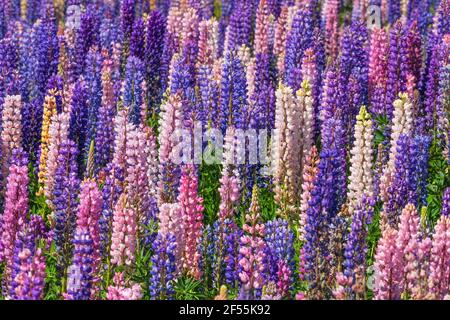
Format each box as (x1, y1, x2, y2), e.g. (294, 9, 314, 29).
(428, 215, 450, 299)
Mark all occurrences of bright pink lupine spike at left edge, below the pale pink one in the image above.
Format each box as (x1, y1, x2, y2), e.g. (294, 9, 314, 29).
(0, 149, 29, 268)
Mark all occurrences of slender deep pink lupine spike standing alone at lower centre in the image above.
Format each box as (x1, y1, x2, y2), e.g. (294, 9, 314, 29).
(178, 165, 203, 279)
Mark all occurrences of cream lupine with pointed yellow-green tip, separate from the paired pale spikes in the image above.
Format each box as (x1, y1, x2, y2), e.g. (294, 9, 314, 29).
(347, 106, 373, 214)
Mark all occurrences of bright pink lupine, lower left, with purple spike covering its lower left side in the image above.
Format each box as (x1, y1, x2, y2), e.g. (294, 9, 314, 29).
(76, 179, 103, 275)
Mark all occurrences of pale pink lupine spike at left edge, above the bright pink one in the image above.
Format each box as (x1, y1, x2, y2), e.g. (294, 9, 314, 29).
(1, 96, 22, 178)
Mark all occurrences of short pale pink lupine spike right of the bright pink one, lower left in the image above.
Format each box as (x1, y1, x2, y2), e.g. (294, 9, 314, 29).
(110, 193, 137, 266)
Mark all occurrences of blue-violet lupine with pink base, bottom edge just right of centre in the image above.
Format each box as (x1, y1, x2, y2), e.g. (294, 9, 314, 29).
(264, 218, 295, 297)
